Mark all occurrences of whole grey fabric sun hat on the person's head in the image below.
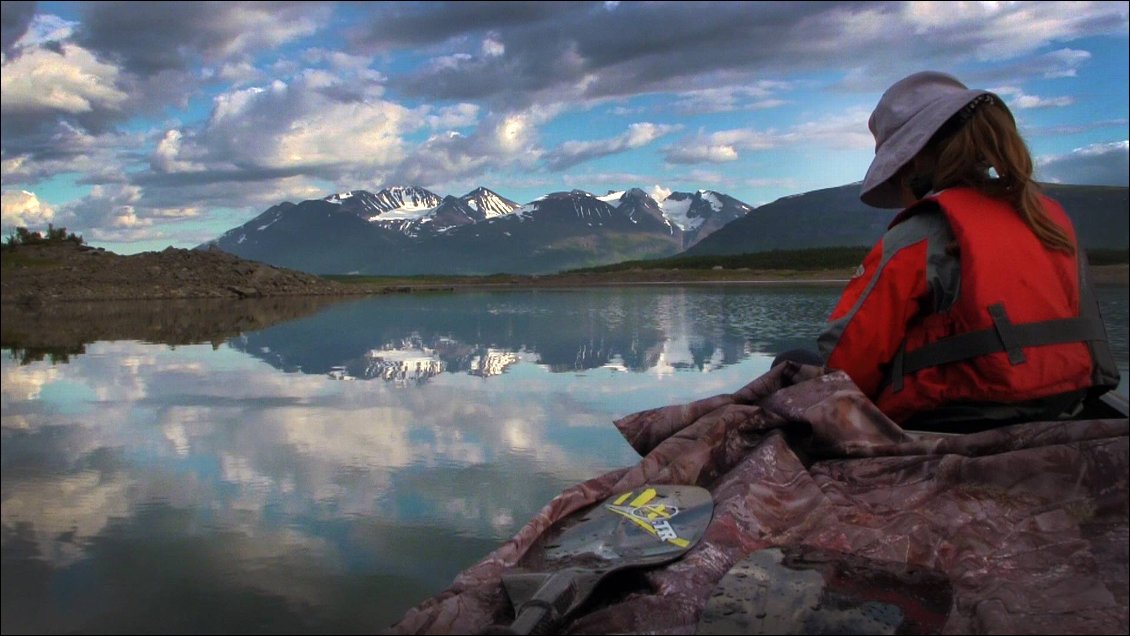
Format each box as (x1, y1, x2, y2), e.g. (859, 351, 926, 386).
(859, 71, 992, 208)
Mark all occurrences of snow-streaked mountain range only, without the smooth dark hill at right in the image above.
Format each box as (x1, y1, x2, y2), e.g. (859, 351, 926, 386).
(206, 186, 753, 275)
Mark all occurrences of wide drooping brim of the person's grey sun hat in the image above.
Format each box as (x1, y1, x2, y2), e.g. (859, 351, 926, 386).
(859, 89, 989, 208)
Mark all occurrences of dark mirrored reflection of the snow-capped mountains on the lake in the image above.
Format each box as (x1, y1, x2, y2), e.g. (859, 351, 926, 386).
(233, 287, 838, 384)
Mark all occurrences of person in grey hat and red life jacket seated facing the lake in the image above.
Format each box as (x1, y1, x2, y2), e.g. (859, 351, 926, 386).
(817, 71, 1119, 432)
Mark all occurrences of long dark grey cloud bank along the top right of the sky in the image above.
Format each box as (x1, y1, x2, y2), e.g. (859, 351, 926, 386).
(363, 2, 1127, 107)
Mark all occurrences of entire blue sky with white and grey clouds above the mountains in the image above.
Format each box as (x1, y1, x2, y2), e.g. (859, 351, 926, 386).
(0, 1, 1130, 253)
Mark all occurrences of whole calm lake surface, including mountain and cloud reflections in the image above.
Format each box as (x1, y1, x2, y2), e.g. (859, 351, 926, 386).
(0, 286, 1130, 634)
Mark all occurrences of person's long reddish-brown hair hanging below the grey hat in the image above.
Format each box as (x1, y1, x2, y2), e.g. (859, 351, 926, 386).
(927, 98, 1076, 254)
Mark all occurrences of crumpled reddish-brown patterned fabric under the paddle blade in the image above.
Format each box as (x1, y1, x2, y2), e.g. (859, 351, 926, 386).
(388, 363, 1130, 634)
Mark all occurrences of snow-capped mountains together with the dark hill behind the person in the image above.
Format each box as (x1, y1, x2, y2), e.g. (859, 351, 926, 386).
(202, 184, 1130, 276)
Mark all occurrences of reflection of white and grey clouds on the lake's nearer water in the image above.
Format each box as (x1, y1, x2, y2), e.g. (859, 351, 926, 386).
(0, 342, 631, 633)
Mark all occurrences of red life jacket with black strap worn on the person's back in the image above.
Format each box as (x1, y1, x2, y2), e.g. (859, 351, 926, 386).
(876, 188, 1106, 421)
